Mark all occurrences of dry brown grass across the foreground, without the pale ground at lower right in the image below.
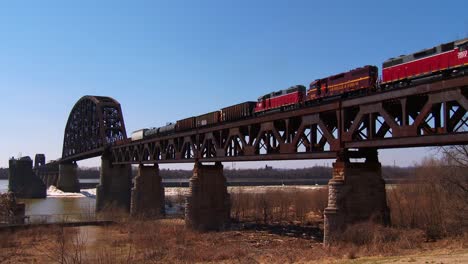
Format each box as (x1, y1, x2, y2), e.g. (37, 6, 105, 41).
(0, 219, 468, 264)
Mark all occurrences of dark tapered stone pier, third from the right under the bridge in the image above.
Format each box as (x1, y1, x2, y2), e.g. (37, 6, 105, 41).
(130, 164, 165, 217)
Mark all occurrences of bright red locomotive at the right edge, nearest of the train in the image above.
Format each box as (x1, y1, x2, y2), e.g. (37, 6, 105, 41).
(382, 38, 468, 84)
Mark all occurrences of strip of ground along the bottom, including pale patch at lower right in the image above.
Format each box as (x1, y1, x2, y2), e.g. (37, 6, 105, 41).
(0, 219, 468, 264)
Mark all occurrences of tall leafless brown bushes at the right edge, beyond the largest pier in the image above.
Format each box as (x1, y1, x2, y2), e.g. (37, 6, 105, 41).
(387, 160, 468, 240)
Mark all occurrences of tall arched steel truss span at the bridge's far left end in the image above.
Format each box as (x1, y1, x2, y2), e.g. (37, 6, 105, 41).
(62, 95, 127, 161)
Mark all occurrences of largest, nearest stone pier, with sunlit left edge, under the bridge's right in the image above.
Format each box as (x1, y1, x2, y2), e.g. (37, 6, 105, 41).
(323, 150, 390, 244)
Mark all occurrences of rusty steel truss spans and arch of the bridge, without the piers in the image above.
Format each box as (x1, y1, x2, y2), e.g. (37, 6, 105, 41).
(61, 76, 468, 164)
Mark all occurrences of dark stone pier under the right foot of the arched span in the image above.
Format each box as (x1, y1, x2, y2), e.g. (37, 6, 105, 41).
(96, 153, 132, 212)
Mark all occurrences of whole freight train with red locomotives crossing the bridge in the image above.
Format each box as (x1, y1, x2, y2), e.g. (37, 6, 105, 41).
(129, 38, 468, 144)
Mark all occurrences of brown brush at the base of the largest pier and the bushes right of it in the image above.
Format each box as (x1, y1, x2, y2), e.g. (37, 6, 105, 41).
(338, 146, 468, 256)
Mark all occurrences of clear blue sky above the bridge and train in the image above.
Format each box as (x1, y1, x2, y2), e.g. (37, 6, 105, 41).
(0, 0, 468, 167)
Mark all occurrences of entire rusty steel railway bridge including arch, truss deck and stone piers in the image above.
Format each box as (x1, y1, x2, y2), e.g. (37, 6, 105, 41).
(33, 76, 468, 243)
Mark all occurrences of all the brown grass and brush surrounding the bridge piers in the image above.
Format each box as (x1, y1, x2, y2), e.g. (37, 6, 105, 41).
(0, 148, 468, 264)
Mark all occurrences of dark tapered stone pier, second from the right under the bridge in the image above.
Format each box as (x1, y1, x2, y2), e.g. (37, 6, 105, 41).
(185, 162, 231, 231)
